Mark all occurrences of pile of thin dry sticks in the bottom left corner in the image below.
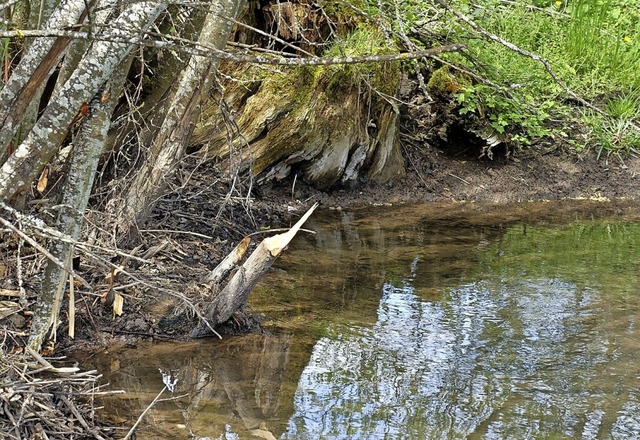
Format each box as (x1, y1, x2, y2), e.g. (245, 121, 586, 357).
(0, 346, 114, 440)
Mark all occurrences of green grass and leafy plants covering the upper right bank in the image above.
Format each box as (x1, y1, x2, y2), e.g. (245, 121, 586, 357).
(370, 0, 640, 155)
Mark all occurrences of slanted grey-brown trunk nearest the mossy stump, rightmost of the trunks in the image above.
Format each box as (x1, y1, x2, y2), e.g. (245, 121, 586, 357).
(118, 0, 244, 237)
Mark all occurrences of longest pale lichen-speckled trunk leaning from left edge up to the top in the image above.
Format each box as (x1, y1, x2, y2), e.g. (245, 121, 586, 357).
(0, 1, 166, 201)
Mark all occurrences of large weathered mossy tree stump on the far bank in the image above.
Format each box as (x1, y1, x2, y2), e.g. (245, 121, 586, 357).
(191, 28, 405, 189)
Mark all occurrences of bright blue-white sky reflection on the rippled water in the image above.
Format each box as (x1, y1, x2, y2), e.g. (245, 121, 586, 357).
(285, 280, 640, 439)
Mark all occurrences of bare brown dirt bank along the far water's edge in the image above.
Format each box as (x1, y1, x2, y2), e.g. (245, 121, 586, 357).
(258, 141, 640, 207)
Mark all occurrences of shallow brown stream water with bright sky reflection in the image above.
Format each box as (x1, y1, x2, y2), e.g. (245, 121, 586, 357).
(90, 202, 640, 439)
